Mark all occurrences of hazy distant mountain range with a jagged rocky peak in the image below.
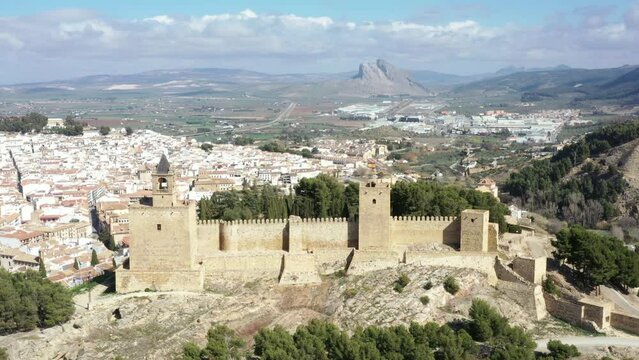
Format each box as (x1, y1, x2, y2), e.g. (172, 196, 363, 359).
(0, 59, 639, 103)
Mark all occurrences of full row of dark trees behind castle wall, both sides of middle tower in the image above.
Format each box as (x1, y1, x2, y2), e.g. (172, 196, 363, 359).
(199, 174, 508, 231)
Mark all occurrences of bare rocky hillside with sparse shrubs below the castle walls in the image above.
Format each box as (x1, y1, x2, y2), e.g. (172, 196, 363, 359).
(0, 265, 608, 359)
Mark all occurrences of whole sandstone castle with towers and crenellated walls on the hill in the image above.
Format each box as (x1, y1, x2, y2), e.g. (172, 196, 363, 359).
(116, 155, 499, 292)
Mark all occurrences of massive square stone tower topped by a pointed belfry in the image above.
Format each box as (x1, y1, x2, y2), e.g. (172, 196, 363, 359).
(116, 155, 204, 292)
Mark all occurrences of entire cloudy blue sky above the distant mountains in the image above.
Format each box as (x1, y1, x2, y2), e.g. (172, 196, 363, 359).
(0, 0, 639, 84)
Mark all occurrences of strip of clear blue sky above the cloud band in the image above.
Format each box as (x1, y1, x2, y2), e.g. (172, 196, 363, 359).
(0, 0, 632, 25)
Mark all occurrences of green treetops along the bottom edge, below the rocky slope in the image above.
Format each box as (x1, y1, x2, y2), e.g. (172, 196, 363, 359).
(183, 300, 579, 360)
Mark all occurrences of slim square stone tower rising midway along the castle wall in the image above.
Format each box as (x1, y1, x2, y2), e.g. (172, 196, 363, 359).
(358, 181, 391, 250)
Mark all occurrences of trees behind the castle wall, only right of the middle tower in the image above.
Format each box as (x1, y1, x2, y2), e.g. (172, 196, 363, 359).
(391, 181, 510, 232)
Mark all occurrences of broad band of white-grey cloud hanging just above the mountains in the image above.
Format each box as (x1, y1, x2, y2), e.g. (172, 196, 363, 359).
(0, 6, 639, 83)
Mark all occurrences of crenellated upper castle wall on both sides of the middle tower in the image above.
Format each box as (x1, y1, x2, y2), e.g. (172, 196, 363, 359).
(197, 216, 478, 258)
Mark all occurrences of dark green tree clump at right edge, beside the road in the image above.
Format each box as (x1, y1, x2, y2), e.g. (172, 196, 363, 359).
(552, 226, 639, 289)
